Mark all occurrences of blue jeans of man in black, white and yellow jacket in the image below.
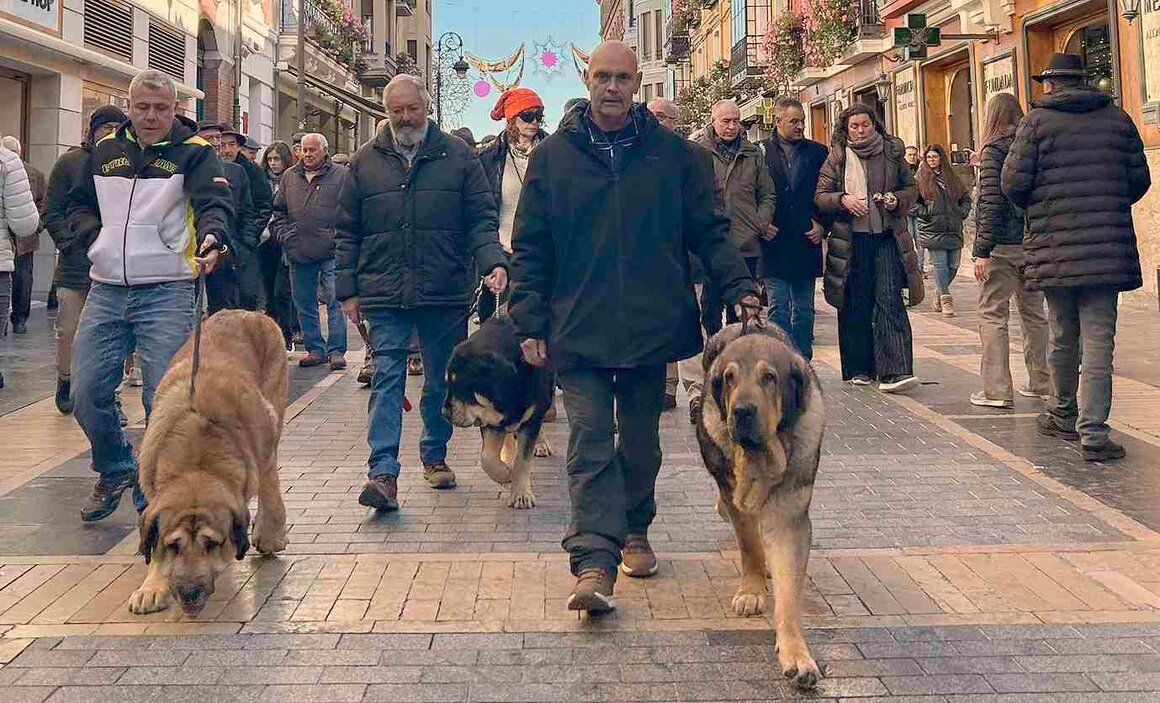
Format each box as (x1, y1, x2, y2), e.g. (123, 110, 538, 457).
(72, 281, 194, 510)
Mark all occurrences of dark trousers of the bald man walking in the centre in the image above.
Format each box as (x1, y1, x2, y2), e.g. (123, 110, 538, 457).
(559, 364, 665, 575)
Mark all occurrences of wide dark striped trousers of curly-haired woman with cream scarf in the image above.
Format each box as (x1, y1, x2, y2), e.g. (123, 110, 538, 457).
(838, 232, 914, 381)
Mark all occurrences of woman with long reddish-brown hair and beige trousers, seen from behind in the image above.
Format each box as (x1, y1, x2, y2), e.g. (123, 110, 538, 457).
(971, 93, 1051, 407)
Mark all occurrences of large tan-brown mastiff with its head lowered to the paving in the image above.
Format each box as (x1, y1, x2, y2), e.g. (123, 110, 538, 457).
(129, 310, 289, 615)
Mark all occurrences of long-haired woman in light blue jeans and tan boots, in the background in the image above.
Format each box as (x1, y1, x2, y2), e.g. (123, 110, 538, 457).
(911, 144, 971, 318)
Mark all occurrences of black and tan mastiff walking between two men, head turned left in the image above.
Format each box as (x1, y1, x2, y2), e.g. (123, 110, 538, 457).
(443, 317, 556, 508)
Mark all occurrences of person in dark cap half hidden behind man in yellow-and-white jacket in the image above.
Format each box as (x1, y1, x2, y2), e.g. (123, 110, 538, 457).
(44, 104, 125, 415)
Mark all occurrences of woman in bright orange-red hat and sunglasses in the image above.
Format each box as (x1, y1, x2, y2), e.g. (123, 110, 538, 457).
(479, 88, 548, 320)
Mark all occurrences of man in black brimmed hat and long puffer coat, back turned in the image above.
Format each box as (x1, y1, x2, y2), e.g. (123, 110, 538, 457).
(1002, 53, 1152, 462)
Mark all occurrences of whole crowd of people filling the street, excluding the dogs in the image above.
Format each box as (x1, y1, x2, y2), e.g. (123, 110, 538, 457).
(0, 42, 1151, 611)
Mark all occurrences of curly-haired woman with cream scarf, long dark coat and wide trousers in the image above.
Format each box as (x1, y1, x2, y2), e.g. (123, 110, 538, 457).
(814, 103, 923, 393)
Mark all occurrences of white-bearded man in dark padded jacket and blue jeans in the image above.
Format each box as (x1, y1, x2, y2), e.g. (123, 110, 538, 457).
(335, 74, 508, 510)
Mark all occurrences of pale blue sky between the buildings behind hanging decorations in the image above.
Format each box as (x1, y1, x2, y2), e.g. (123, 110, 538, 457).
(432, 0, 600, 139)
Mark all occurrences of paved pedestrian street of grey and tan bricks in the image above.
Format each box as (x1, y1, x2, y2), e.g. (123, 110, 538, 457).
(0, 287, 1160, 703)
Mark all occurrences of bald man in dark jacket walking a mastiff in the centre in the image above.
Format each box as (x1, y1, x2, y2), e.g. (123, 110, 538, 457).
(510, 42, 759, 613)
